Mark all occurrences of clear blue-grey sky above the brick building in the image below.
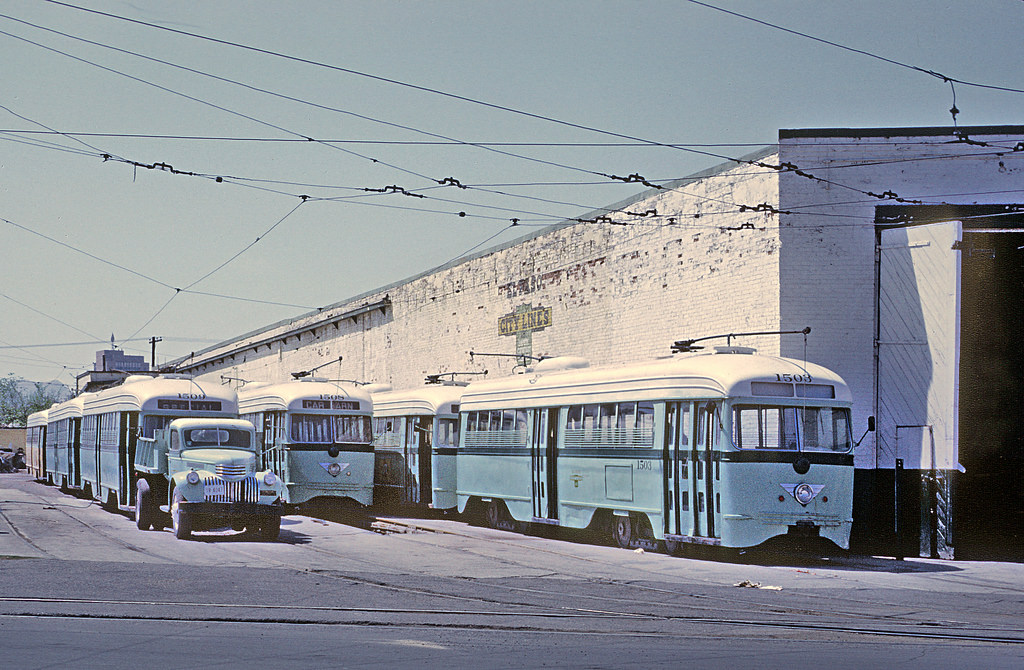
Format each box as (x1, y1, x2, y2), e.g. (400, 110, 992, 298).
(0, 0, 1024, 387)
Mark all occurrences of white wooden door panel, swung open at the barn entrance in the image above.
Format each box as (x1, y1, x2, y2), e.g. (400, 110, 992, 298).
(877, 221, 962, 469)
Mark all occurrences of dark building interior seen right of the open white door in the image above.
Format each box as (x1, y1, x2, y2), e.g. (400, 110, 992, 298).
(953, 227, 1024, 560)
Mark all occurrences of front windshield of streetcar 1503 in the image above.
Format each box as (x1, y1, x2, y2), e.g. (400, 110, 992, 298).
(732, 405, 853, 453)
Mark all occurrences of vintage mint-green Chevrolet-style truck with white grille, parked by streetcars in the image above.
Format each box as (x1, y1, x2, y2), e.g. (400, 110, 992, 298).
(134, 418, 284, 542)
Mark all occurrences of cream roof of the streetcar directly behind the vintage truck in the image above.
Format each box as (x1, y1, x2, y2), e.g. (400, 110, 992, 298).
(85, 375, 238, 414)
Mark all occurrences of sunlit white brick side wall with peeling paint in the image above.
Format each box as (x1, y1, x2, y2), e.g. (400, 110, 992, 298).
(188, 153, 780, 388)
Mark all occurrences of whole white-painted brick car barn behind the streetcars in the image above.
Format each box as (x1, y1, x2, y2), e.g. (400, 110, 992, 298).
(172, 126, 1024, 558)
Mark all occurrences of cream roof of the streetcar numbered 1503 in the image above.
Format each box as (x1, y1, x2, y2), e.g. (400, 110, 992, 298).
(461, 352, 852, 412)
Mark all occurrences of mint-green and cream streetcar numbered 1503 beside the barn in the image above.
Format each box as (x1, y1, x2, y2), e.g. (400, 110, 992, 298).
(456, 346, 853, 552)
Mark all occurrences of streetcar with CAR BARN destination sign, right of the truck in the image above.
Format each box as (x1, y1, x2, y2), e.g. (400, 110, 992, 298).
(239, 379, 374, 505)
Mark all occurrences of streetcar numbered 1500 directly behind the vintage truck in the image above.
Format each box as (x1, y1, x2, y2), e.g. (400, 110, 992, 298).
(78, 375, 239, 509)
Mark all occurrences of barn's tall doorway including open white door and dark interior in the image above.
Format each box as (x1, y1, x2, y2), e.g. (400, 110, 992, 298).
(871, 205, 1024, 560)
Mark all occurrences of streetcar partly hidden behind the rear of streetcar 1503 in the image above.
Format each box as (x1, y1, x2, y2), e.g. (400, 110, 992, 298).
(373, 383, 466, 510)
